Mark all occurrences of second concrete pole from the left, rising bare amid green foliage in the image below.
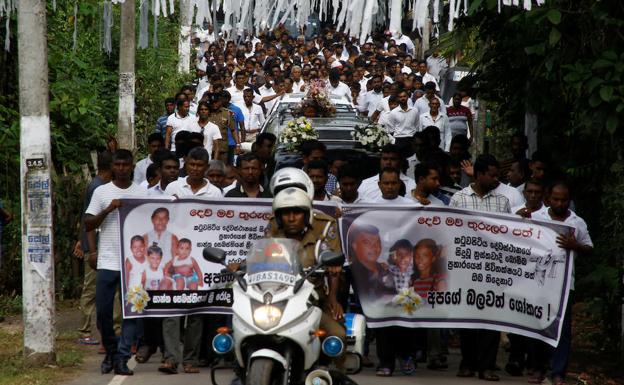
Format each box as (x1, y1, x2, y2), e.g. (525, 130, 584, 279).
(117, 0, 136, 151)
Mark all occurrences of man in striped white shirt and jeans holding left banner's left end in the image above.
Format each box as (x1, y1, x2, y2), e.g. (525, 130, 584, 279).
(84, 150, 145, 375)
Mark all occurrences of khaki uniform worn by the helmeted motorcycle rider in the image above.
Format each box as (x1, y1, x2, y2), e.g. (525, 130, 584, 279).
(265, 211, 347, 369)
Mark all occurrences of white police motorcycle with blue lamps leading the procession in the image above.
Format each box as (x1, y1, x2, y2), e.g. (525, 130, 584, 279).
(203, 238, 365, 385)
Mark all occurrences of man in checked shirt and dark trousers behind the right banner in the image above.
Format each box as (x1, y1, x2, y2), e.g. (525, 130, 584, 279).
(450, 154, 511, 381)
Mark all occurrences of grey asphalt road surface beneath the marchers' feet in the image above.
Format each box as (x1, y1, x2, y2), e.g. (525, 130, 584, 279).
(65, 348, 550, 385)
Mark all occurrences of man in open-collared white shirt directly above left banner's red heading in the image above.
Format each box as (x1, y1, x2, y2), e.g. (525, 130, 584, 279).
(165, 147, 223, 198)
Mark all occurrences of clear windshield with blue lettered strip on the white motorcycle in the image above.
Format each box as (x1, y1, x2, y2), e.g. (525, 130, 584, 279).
(246, 238, 301, 285)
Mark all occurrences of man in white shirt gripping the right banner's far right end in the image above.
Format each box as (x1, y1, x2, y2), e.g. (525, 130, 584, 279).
(533, 182, 594, 385)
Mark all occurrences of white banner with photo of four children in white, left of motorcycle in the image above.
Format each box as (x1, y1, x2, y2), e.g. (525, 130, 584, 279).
(119, 198, 336, 318)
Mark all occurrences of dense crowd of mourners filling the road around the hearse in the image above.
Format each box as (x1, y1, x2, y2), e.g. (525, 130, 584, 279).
(76, 26, 592, 384)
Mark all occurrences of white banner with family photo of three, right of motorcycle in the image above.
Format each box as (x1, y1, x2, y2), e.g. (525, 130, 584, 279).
(340, 205, 574, 346)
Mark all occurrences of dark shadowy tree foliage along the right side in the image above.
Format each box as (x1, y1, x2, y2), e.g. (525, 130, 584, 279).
(446, 0, 624, 348)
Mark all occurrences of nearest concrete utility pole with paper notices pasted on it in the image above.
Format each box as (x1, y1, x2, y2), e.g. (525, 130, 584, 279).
(17, 0, 56, 366)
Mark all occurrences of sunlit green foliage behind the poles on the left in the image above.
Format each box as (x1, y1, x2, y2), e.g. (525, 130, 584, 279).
(0, 0, 184, 298)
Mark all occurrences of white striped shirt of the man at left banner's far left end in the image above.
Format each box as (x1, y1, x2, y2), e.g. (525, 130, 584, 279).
(85, 182, 145, 271)
